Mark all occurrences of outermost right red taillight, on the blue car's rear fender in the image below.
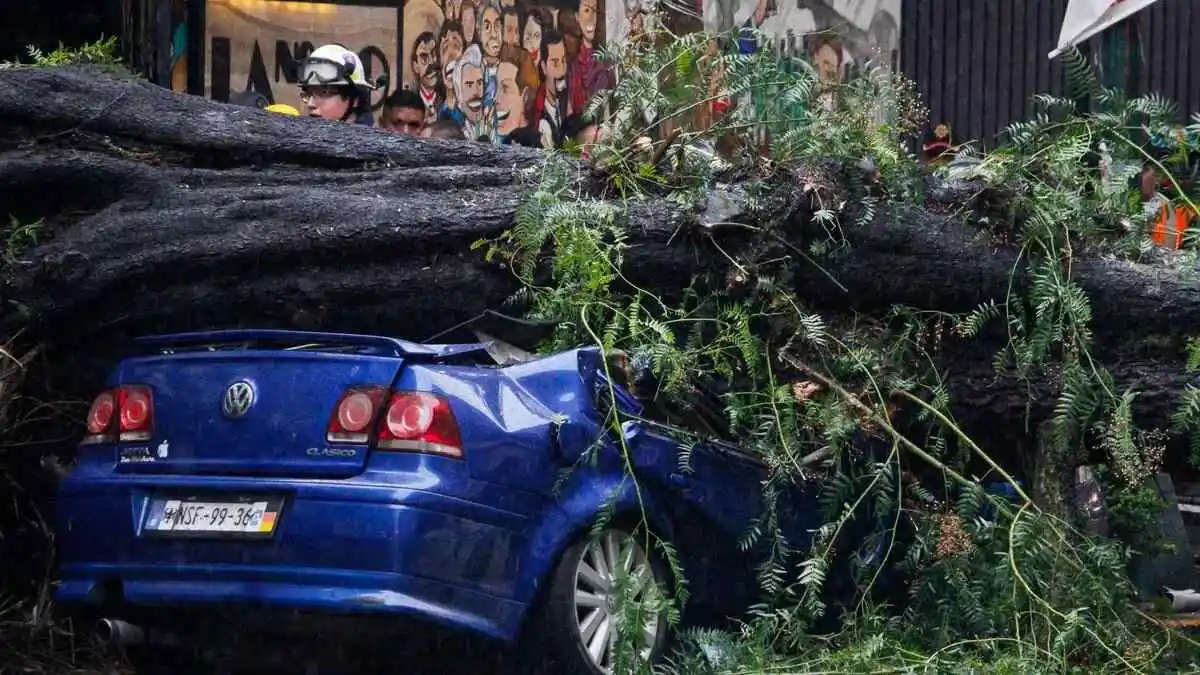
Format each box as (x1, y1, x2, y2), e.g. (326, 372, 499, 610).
(378, 392, 462, 458)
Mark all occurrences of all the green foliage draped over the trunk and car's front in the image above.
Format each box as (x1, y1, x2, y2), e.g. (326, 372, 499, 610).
(480, 21, 1200, 674)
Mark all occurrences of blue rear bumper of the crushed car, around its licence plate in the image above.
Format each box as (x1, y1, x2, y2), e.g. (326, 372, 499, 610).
(56, 477, 540, 640)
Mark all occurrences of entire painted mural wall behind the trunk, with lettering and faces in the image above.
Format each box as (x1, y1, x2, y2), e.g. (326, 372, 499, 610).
(187, 0, 901, 145)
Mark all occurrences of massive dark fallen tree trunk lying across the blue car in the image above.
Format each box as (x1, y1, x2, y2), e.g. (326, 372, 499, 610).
(0, 68, 1200, 446)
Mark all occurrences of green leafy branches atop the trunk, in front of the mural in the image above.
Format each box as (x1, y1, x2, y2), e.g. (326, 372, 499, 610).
(588, 22, 925, 205)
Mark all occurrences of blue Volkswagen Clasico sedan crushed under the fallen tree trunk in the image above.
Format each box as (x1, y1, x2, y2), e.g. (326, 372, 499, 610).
(56, 330, 888, 675)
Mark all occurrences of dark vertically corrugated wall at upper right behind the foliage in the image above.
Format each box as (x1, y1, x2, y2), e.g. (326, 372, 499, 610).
(900, 0, 1200, 147)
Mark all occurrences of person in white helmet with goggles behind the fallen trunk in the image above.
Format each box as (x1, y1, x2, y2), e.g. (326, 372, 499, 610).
(299, 44, 376, 126)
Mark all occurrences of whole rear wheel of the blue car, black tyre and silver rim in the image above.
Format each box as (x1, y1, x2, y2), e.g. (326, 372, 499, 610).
(529, 527, 668, 675)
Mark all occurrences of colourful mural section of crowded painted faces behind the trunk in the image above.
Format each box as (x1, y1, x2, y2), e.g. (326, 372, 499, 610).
(401, 0, 613, 147)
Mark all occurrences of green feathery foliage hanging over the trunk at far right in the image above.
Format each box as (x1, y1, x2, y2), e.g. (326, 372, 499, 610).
(946, 44, 1194, 523)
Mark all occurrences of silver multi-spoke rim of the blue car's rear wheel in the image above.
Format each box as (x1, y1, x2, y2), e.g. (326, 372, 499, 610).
(575, 530, 660, 673)
